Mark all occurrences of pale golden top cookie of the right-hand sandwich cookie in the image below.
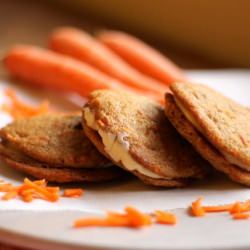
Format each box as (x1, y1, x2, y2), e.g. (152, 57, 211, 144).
(170, 83, 250, 170)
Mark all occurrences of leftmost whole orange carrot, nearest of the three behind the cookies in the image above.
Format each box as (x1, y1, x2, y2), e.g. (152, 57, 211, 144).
(4, 45, 162, 102)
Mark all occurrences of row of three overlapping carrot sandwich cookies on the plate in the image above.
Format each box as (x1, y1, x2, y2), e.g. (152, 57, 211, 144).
(0, 83, 250, 187)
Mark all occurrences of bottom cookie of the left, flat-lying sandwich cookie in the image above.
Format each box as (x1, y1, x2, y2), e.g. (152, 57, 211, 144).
(0, 143, 124, 183)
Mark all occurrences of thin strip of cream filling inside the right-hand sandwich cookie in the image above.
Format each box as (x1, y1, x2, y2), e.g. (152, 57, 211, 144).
(174, 97, 250, 169)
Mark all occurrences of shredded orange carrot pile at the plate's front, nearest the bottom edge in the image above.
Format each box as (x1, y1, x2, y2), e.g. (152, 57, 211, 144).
(74, 206, 177, 228)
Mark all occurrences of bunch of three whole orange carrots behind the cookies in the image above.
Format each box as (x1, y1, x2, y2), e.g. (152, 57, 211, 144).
(4, 27, 186, 104)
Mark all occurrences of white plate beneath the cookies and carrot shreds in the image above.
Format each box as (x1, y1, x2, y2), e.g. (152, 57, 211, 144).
(0, 71, 250, 250)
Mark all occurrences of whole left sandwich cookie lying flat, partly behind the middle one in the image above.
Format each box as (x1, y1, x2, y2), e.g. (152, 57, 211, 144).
(0, 114, 124, 183)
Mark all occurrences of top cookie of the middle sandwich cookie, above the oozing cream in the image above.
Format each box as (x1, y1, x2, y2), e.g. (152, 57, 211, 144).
(83, 90, 206, 179)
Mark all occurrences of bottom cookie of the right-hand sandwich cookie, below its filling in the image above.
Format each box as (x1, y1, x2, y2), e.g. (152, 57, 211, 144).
(165, 94, 250, 186)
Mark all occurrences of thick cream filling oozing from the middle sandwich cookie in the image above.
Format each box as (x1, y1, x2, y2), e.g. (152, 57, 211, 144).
(84, 108, 163, 179)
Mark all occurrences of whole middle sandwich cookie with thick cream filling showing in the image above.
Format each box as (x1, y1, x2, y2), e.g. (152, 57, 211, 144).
(83, 90, 206, 187)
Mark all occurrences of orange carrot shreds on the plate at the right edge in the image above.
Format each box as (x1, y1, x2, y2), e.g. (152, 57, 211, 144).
(190, 197, 250, 220)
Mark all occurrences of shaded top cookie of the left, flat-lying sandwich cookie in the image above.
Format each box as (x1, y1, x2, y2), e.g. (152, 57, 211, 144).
(0, 114, 109, 168)
